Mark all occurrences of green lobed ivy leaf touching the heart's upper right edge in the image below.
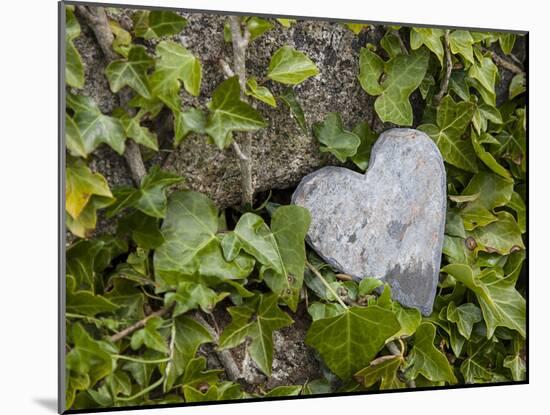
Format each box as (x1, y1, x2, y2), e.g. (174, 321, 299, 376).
(418, 95, 478, 173)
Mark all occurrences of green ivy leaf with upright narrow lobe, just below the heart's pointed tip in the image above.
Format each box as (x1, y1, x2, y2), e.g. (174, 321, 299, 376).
(407, 322, 457, 384)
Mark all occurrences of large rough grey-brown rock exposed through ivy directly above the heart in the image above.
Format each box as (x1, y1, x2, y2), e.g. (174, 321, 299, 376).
(162, 14, 386, 207)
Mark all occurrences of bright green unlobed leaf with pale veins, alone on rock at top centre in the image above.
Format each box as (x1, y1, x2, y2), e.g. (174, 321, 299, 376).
(267, 46, 319, 85)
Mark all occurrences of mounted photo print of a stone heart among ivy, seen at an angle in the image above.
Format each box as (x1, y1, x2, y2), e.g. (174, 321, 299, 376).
(59, 2, 528, 412)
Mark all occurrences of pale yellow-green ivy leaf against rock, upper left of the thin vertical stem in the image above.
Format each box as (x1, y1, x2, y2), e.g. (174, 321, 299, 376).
(151, 40, 202, 96)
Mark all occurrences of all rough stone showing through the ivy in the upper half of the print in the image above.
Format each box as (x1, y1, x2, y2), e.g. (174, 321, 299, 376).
(74, 9, 394, 208)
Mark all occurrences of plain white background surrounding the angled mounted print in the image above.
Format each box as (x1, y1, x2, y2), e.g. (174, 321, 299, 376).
(0, 0, 550, 415)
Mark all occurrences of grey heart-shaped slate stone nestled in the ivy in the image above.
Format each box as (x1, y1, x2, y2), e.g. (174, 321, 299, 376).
(292, 128, 447, 315)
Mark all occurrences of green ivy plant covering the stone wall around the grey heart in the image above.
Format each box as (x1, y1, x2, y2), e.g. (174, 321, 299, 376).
(65, 6, 527, 409)
